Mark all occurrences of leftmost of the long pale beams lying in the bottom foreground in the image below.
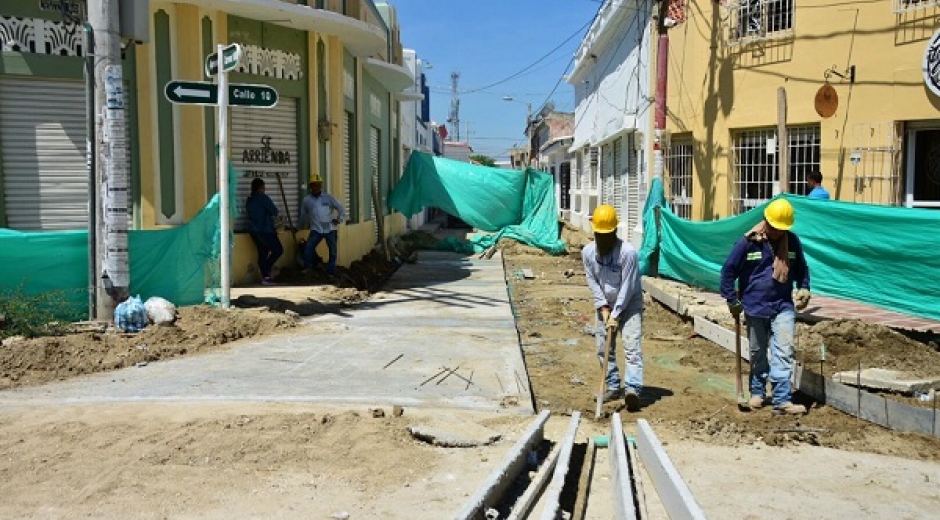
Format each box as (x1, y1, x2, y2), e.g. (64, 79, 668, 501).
(454, 410, 551, 520)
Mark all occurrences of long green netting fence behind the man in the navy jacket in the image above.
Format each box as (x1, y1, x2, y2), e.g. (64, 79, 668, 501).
(641, 179, 940, 320)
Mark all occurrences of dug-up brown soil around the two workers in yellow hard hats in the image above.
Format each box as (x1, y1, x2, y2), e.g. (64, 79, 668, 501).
(503, 225, 940, 461)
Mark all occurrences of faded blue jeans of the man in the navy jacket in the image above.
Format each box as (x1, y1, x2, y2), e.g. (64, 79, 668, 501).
(747, 310, 796, 406)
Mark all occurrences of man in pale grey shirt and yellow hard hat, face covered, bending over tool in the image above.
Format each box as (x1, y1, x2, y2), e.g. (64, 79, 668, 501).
(581, 204, 643, 411)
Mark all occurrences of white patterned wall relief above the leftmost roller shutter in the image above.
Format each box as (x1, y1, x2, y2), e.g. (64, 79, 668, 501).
(0, 16, 85, 56)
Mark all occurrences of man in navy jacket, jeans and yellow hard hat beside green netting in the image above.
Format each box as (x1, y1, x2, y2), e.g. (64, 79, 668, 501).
(721, 198, 810, 415)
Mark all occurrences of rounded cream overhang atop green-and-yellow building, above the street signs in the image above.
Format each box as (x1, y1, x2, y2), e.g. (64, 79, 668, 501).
(177, 0, 388, 58)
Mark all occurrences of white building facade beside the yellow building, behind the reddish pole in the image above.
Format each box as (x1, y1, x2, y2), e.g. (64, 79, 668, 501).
(563, 0, 653, 243)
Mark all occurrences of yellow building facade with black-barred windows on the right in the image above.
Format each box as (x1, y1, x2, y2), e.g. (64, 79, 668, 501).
(651, 0, 940, 220)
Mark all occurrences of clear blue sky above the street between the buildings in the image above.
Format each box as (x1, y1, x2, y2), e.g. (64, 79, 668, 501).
(390, 0, 601, 159)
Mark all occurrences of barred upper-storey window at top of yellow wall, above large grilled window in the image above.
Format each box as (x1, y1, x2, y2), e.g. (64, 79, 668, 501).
(728, 0, 793, 43)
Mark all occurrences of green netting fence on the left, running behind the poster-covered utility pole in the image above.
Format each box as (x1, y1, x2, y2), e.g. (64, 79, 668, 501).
(0, 165, 241, 320)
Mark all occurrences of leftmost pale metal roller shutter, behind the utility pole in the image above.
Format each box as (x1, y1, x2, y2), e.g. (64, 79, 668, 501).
(0, 76, 88, 231)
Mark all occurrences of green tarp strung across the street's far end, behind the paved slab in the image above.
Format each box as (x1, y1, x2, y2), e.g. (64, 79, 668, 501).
(388, 152, 565, 254)
